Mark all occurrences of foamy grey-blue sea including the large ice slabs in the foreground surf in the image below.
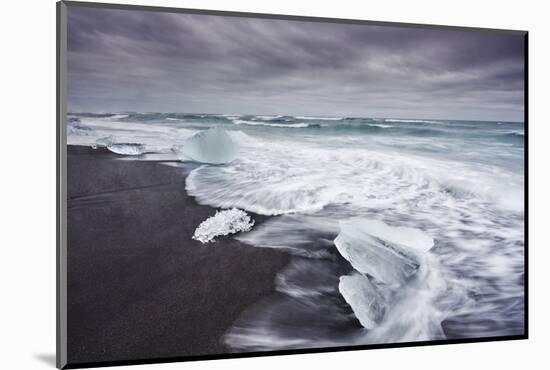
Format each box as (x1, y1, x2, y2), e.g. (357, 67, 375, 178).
(67, 113, 525, 351)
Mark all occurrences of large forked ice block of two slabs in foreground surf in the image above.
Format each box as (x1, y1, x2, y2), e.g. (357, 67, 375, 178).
(334, 218, 434, 330)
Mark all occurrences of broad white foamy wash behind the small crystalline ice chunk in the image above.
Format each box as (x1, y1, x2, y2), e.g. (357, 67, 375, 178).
(187, 137, 522, 215)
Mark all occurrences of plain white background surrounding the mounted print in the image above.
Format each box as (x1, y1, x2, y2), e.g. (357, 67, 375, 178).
(0, 0, 550, 370)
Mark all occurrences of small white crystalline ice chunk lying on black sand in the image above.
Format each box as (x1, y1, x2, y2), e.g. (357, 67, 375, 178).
(193, 208, 254, 244)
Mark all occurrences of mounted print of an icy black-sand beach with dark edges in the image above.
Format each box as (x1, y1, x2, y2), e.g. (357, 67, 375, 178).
(57, 2, 527, 367)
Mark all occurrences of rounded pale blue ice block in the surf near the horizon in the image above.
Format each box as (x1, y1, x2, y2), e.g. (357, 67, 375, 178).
(177, 126, 239, 164)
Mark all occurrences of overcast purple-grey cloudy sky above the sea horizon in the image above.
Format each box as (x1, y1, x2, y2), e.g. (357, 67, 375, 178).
(68, 7, 524, 121)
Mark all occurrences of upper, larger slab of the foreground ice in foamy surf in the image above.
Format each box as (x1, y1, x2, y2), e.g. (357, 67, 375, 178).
(334, 219, 433, 286)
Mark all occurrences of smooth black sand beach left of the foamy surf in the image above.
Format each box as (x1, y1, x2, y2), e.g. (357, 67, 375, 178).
(67, 146, 288, 364)
